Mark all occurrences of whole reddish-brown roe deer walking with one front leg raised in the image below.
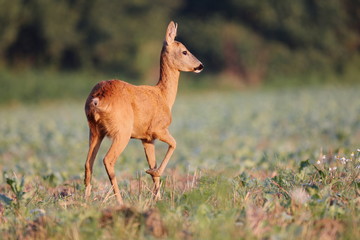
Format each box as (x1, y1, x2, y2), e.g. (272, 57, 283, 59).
(84, 21, 203, 204)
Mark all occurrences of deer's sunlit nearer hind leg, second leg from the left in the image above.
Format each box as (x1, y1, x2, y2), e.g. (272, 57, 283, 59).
(104, 134, 130, 205)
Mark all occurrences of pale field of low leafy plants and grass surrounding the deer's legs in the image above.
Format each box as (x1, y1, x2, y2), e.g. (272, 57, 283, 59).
(0, 87, 360, 239)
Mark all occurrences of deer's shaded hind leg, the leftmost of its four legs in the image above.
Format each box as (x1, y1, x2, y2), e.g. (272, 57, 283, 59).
(84, 129, 104, 199)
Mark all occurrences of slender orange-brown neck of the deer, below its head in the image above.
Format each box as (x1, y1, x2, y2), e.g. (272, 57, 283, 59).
(157, 56, 180, 109)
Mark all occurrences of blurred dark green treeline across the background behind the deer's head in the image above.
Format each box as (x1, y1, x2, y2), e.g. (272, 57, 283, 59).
(0, 0, 360, 85)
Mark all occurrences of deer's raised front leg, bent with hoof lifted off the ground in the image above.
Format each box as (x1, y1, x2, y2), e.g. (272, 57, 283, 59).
(146, 129, 176, 177)
